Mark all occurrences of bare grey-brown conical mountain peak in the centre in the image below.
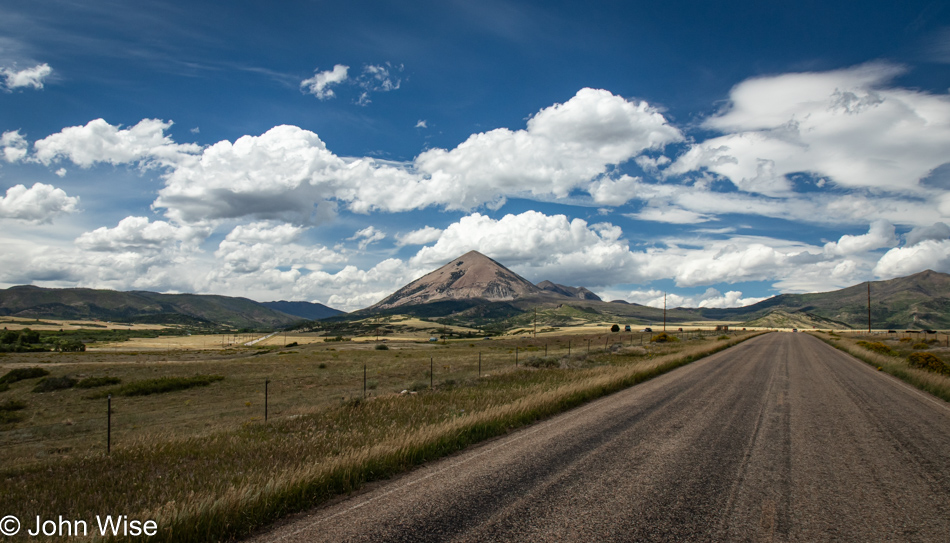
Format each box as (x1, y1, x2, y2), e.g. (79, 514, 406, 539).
(374, 251, 543, 311)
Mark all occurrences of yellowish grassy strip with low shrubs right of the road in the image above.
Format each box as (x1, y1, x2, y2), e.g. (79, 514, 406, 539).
(814, 332, 950, 402)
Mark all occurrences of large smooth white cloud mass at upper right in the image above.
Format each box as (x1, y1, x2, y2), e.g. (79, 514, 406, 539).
(665, 64, 950, 195)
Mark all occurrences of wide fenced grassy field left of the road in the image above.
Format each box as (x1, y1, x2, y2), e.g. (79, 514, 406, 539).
(0, 333, 760, 541)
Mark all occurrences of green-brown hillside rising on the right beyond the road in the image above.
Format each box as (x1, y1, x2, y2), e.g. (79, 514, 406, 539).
(697, 270, 950, 329)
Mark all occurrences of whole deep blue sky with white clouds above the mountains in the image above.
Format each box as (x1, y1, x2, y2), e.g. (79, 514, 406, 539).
(0, 1, 950, 310)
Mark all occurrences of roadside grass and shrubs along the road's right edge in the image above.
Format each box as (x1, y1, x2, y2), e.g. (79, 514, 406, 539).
(814, 332, 950, 402)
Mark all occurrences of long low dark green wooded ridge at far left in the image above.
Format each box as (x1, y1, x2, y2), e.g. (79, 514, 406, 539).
(0, 286, 300, 328)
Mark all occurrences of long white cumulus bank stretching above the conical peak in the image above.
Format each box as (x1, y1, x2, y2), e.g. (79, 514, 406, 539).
(147, 89, 682, 222)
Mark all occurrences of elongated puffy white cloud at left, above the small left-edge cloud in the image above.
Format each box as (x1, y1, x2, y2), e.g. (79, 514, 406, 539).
(33, 119, 201, 168)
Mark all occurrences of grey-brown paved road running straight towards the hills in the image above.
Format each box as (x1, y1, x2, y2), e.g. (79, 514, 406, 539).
(249, 333, 950, 542)
